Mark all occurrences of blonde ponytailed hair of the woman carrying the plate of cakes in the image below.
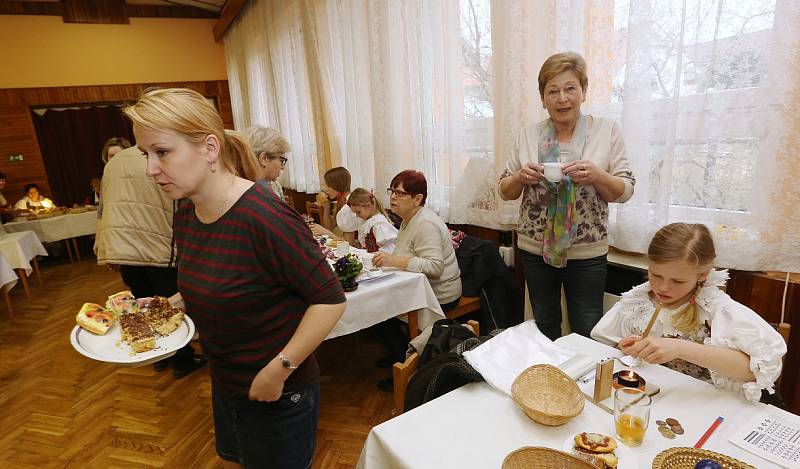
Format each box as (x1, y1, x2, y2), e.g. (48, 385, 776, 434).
(125, 88, 258, 181)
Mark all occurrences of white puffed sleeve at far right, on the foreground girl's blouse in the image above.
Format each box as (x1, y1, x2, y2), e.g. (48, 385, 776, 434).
(705, 295, 786, 402)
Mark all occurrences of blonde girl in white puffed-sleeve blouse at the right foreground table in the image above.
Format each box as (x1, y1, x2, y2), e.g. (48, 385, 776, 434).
(591, 223, 786, 402)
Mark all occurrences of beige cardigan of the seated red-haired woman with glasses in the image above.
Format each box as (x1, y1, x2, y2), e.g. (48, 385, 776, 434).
(394, 207, 461, 304)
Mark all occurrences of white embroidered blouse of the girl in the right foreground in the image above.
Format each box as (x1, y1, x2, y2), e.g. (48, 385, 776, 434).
(591, 270, 786, 402)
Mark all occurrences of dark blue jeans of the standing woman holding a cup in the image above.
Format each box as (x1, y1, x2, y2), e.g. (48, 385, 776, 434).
(522, 251, 608, 340)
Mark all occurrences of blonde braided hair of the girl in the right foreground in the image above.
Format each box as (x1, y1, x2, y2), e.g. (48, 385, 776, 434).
(647, 223, 717, 334)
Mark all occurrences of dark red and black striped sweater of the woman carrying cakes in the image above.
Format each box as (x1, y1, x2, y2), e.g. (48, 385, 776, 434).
(175, 184, 345, 395)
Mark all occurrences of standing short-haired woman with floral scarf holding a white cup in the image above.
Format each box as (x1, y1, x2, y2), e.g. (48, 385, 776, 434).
(500, 52, 636, 339)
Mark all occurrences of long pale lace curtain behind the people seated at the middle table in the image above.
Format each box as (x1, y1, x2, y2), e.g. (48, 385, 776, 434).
(225, 0, 466, 214)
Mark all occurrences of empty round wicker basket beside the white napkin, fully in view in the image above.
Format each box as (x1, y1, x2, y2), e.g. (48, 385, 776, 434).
(511, 365, 584, 426)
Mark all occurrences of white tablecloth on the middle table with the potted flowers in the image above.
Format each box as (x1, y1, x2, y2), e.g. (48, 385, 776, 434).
(327, 271, 444, 339)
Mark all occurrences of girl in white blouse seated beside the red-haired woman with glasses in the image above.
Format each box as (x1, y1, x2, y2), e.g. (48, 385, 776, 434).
(347, 187, 397, 254)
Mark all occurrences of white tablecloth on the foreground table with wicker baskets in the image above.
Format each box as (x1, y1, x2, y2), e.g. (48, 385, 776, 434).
(358, 334, 790, 469)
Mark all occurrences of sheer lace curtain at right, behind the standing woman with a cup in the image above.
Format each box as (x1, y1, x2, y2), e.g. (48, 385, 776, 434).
(472, 0, 800, 271)
